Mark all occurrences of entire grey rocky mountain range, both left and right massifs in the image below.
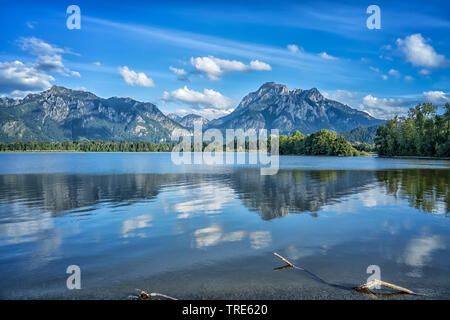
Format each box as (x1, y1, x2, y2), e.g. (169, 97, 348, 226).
(0, 82, 384, 142)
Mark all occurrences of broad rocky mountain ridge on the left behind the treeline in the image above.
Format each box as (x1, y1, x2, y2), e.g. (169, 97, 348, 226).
(0, 86, 190, 142)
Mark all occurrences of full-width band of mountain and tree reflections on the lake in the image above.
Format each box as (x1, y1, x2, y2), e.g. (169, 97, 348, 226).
(0, 169, 450, 220)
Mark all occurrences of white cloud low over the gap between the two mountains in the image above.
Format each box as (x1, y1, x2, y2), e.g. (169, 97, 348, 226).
(163, 86, 233, 109)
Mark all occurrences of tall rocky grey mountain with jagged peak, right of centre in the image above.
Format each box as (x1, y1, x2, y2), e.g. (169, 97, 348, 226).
(208, 82, 384, 134)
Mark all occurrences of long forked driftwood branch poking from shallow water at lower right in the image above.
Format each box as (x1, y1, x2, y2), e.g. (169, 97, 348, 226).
(273, 252, 417, 298)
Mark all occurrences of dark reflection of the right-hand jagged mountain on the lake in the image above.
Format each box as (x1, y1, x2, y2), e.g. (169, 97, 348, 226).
(232, 170, 376, 220)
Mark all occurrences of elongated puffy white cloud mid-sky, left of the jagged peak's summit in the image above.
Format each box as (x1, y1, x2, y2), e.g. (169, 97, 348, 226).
(191, 56, 272, 80)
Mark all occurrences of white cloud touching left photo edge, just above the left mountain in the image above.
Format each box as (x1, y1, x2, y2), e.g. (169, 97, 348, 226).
(0, 61, 55, 95)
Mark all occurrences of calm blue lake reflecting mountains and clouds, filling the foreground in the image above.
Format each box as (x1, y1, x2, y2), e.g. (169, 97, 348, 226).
(0, 153, 450, 299)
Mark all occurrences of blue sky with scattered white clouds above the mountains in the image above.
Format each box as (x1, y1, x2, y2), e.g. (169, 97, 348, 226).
(0, 0, 450, 118)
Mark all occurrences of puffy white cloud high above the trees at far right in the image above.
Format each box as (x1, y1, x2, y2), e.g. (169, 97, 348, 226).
(397, 33, 448, 68)
